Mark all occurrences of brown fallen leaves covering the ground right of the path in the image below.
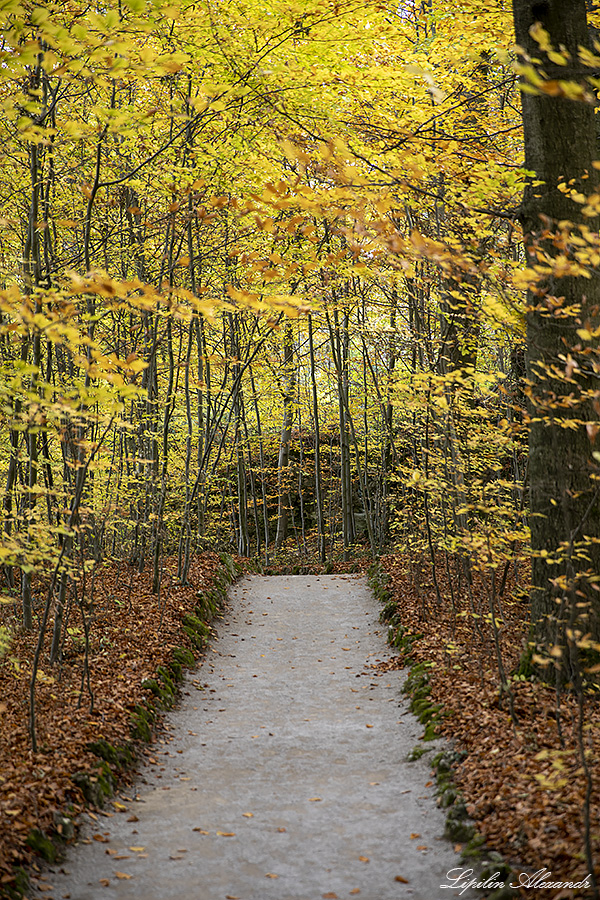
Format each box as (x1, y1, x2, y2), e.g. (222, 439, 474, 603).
(383, 556, 600, 900)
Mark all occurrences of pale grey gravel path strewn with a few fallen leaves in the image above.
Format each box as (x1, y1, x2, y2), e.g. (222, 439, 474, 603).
(32, 575, 474, 900)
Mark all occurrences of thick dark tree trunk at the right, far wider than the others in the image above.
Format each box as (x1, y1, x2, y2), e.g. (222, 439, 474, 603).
(513, 0, 600, 680)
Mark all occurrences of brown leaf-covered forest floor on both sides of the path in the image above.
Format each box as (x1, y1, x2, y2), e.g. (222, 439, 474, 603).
(0, 554, 600, 900)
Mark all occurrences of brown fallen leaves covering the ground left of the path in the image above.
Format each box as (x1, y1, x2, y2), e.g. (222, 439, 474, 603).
(0, 553, 224, 893)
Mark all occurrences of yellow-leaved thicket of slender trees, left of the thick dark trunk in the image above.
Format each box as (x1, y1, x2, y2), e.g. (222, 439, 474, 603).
(1, 2, 526, 624)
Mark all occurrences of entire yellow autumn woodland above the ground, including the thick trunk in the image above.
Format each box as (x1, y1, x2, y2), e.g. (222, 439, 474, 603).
(0, 0, 600, 892)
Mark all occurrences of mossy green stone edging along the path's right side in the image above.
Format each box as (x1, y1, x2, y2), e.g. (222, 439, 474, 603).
(368, 562, 519, 900)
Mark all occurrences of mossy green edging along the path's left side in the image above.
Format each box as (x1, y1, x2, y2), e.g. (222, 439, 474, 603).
(0, 553, 242, 900)
